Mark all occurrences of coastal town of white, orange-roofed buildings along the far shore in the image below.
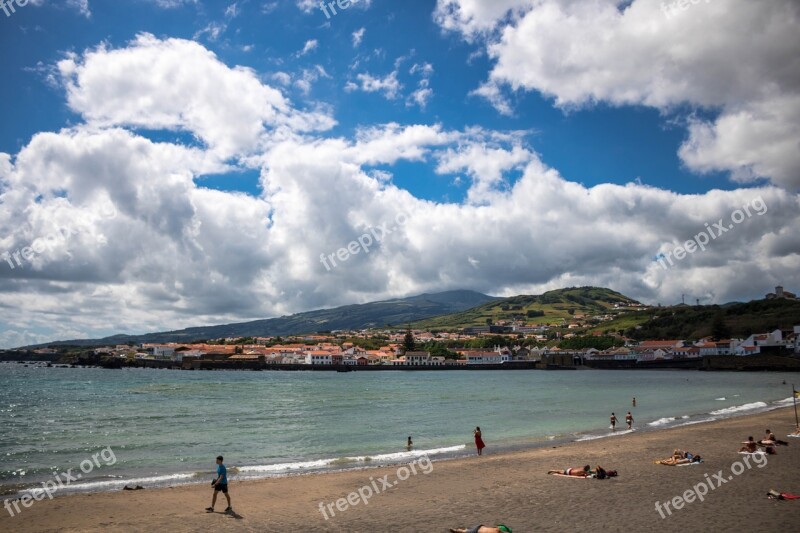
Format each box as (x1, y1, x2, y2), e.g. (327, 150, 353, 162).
(7, 286, 800, 371)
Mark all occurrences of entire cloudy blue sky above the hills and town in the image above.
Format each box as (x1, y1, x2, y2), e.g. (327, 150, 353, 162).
(0, 0, 800, 348)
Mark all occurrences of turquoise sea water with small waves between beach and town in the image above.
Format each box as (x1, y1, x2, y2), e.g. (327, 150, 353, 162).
(0, 364, 798, 494)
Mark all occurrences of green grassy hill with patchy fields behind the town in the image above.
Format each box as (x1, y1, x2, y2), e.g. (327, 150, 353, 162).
(411, 287, 641, 329)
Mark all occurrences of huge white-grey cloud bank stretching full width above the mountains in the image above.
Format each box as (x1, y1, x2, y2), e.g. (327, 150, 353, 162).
(0, 35, 800, 346)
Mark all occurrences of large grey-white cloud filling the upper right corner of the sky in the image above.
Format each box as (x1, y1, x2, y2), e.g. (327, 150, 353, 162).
(436, 0, 800, 188)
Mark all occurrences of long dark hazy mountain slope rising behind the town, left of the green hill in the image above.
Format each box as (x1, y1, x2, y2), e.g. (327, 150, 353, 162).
(30, 291, 496, 348)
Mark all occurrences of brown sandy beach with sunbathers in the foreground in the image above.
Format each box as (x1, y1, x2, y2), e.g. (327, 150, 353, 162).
(0, 408, 800, 533)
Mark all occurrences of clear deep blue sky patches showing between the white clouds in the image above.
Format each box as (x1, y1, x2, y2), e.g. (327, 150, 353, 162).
(0, 0, 736, 197)
